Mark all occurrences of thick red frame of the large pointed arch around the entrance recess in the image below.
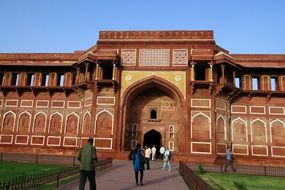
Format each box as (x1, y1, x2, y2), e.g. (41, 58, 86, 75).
(117, 75, 185, 151)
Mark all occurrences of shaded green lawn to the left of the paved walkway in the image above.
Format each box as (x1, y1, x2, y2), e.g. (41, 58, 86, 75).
(0, 162, 70, 181)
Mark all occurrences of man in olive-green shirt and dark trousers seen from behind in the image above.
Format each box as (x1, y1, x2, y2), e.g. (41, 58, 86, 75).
(77, 138, 97, 190)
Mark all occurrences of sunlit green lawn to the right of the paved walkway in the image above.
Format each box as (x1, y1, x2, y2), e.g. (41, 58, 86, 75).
(201, 173, 285, 190)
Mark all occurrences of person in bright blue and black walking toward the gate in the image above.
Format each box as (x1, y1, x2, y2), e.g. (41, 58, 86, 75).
(132, 144, 145, 185)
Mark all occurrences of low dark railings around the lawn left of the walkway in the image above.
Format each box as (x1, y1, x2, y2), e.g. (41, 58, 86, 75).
(0, 154, 113, 190)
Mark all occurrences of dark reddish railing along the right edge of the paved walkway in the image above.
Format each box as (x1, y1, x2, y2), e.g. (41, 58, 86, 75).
(179, 161, 212, 190)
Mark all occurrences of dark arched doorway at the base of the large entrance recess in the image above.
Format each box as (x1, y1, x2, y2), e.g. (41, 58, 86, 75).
(143, 129, 161, 154)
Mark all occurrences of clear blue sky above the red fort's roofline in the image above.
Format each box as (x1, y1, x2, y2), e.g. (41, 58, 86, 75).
(0, 0, 285, 54)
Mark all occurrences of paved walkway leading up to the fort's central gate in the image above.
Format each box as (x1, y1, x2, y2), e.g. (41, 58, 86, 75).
(60, 160, 188, 190)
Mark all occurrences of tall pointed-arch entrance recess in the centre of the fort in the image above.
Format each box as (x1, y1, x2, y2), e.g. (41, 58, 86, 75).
(122, 76, 183, 152)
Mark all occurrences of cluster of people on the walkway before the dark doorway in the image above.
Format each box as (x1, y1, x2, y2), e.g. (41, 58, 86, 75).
(129, 144, 171, 185)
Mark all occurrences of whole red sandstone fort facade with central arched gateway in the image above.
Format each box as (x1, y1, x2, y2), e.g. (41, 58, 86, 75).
(0, 31, 285, 164)
